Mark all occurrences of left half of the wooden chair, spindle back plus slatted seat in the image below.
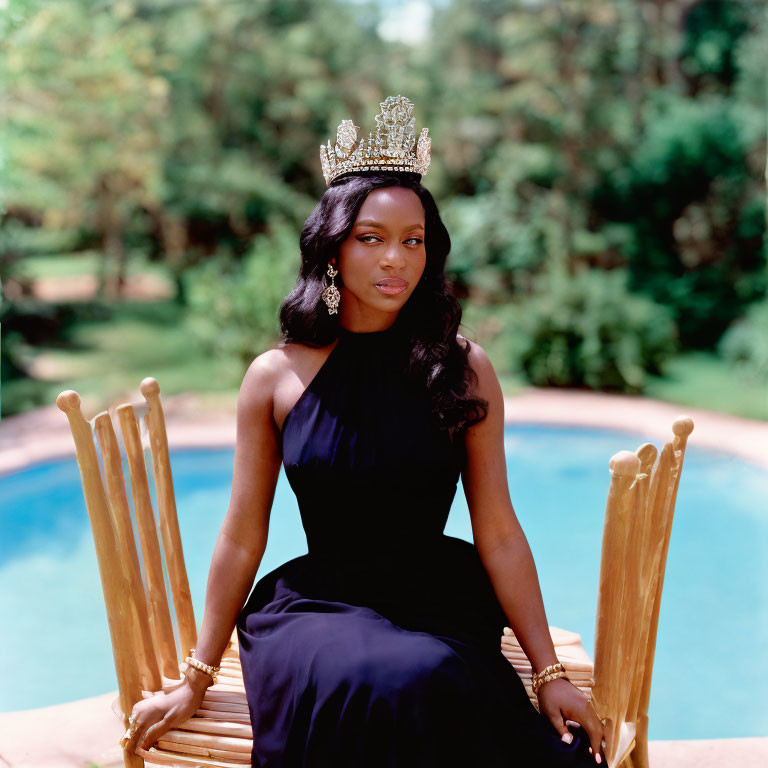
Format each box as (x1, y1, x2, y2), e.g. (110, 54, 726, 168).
(56, 378, 252, 768)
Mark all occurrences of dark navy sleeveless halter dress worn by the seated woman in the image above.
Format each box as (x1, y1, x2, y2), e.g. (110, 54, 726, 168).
(237, 323, 596, 768)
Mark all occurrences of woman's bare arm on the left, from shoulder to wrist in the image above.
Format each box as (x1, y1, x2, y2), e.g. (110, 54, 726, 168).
(195, 350, 281, 685)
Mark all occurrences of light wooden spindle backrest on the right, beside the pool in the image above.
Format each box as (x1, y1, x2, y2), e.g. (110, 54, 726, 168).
(592, 416, 693, 768)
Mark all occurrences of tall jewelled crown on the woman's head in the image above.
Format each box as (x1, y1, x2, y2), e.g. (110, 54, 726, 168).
(320, 95, 432, 186)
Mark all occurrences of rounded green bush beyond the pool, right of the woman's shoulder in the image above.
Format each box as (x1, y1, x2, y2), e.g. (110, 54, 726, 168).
(486, 269, 676, 392)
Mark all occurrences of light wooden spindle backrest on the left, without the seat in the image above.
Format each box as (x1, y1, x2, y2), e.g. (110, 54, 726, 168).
(56, 378, 197, 736)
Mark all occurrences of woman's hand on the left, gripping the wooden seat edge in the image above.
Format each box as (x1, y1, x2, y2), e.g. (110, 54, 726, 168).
(120, 673, 210, 753)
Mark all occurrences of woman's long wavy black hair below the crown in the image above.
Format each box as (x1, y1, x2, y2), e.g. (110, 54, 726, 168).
(280, 171, 488, 440)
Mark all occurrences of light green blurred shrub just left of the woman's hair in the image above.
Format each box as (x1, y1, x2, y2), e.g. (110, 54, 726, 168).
(184, 220, 300, 366)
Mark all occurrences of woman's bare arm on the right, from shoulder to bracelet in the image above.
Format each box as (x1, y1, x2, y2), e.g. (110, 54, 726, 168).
(462, 342, 557, 671)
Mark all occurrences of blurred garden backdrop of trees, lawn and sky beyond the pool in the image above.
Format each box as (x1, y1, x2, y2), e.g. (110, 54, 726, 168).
(0, 0, 768, 418)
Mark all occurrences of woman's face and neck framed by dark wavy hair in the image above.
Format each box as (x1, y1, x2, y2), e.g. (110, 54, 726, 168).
(336, 187, 427, 331)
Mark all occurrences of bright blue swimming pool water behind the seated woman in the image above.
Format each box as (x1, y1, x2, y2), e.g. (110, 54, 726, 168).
(0, 425, 768, 739)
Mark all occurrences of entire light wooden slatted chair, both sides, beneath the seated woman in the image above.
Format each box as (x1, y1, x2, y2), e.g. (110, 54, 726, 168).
(56, 378, 693, 768)
